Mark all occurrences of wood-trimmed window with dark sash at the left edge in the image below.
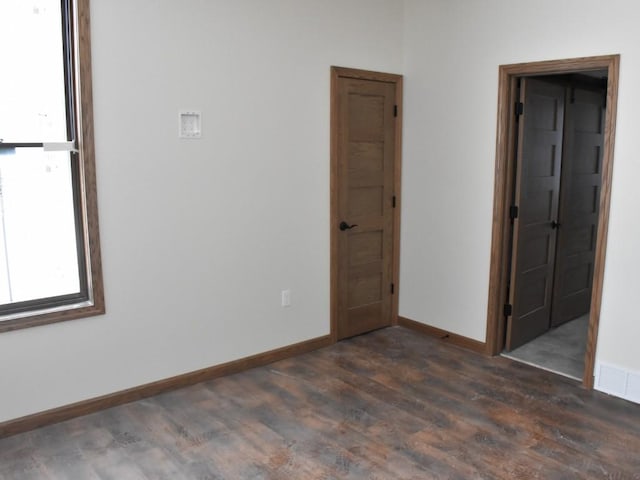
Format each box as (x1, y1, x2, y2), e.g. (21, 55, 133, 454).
(0, 0, 104, 332)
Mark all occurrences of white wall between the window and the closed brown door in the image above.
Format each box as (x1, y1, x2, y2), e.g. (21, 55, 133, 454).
(0, 0, 403, 421)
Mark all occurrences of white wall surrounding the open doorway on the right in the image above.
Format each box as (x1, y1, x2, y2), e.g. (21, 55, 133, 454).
(400, 0, 640, 378)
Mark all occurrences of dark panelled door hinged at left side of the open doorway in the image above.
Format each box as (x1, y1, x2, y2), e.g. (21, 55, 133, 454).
(506, 78, 565, 350)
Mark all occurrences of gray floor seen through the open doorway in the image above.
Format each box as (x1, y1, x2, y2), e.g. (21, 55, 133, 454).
(502, 315, 589, 380)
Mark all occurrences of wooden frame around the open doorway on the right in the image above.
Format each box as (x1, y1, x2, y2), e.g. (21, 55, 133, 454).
(486, 55, 620, 389)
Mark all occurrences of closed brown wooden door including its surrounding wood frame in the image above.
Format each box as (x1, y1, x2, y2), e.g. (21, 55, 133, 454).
(331, 67, 401, 339)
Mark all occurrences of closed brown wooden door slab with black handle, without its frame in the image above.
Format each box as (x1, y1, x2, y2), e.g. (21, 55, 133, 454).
(337, 78, 396, 339)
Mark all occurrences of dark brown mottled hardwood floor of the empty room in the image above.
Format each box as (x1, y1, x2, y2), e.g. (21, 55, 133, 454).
(0, 327, 640, 480)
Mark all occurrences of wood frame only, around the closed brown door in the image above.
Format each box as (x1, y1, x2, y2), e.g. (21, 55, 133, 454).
(329, 66, 402, 343)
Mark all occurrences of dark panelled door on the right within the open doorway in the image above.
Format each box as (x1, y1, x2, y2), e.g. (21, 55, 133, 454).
(551, 87, 605, 326)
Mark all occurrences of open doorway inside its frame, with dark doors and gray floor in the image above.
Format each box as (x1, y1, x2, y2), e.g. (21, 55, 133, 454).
(503, 70, 607, 379)
